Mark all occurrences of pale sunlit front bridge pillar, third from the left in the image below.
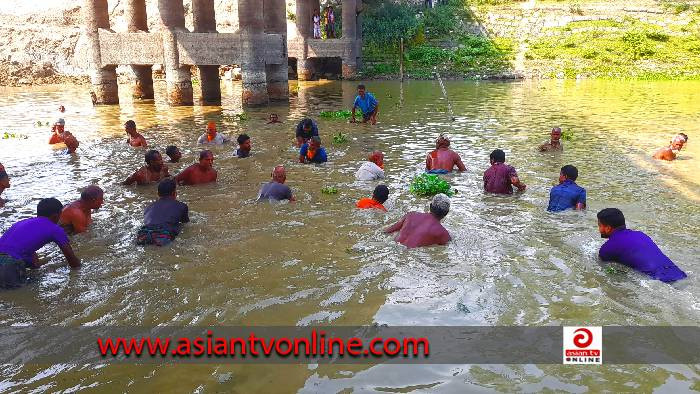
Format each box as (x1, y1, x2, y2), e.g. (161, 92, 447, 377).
(158, 0, 194, 106)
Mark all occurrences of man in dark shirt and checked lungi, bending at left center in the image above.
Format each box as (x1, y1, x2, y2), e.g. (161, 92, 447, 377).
(136, 179, 190, 246)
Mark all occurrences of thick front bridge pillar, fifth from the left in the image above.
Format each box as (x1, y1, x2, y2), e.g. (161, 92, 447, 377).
(238, 0, 270, 106)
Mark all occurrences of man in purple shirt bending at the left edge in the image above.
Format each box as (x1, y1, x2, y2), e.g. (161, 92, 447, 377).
(0, 198, 80, 288)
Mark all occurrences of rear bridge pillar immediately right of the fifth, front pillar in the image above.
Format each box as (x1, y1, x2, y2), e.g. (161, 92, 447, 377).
(263, 0, 289, 101)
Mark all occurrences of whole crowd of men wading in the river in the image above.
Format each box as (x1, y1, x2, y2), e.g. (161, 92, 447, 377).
(0, 85, 688, 288)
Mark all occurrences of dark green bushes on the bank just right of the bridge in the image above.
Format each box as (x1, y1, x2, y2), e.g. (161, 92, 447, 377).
(361, 0, 514, 79)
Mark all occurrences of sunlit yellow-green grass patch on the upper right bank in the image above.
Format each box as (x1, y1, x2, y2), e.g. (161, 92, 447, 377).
(525, 18, 700, 79)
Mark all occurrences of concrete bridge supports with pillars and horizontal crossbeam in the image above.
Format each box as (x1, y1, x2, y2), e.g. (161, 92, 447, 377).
(83, 0, 362, 106)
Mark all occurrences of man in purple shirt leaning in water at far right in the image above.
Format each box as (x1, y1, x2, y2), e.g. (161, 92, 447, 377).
(598, 208, 687, 283)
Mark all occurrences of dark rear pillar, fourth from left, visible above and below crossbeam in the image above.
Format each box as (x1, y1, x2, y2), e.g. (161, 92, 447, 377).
(192, 0, 221, 105)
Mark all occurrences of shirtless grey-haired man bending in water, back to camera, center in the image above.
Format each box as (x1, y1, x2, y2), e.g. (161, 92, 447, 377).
(384, 193, 451, 248)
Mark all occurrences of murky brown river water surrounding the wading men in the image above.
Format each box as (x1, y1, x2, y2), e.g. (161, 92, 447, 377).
(0, 81, 700, 392)
